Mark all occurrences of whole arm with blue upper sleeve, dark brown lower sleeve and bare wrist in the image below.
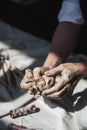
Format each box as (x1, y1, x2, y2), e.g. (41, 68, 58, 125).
(43, 0, 84, 68)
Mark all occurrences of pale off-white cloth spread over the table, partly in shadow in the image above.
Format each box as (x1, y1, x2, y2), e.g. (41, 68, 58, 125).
(0, 22, 87, 130)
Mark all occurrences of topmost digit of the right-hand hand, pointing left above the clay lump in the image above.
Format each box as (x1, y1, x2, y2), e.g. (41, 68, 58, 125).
(45, 64, 64, 76)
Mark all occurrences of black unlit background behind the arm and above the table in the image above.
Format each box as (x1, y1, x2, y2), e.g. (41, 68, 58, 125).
(0, 0, 87, 54)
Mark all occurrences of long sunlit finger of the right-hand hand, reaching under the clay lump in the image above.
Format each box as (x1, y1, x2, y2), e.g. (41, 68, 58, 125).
(42, 78, 66, 95)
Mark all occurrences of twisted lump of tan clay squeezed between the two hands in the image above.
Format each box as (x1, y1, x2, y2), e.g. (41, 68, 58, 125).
(22, 69, 55, 95)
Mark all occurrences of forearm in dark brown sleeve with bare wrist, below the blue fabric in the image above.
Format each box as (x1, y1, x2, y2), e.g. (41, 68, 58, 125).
(43, 22, 80, 67)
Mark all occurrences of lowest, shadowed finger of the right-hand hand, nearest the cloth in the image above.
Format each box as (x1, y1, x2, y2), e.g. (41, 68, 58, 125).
(46, 84, 70, 99)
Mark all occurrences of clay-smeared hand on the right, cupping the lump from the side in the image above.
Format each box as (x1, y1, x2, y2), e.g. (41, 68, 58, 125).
(42, 63, 79, 98)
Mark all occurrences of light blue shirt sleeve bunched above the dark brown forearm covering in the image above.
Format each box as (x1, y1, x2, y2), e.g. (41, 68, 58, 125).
(58, 0, 84, 25)
